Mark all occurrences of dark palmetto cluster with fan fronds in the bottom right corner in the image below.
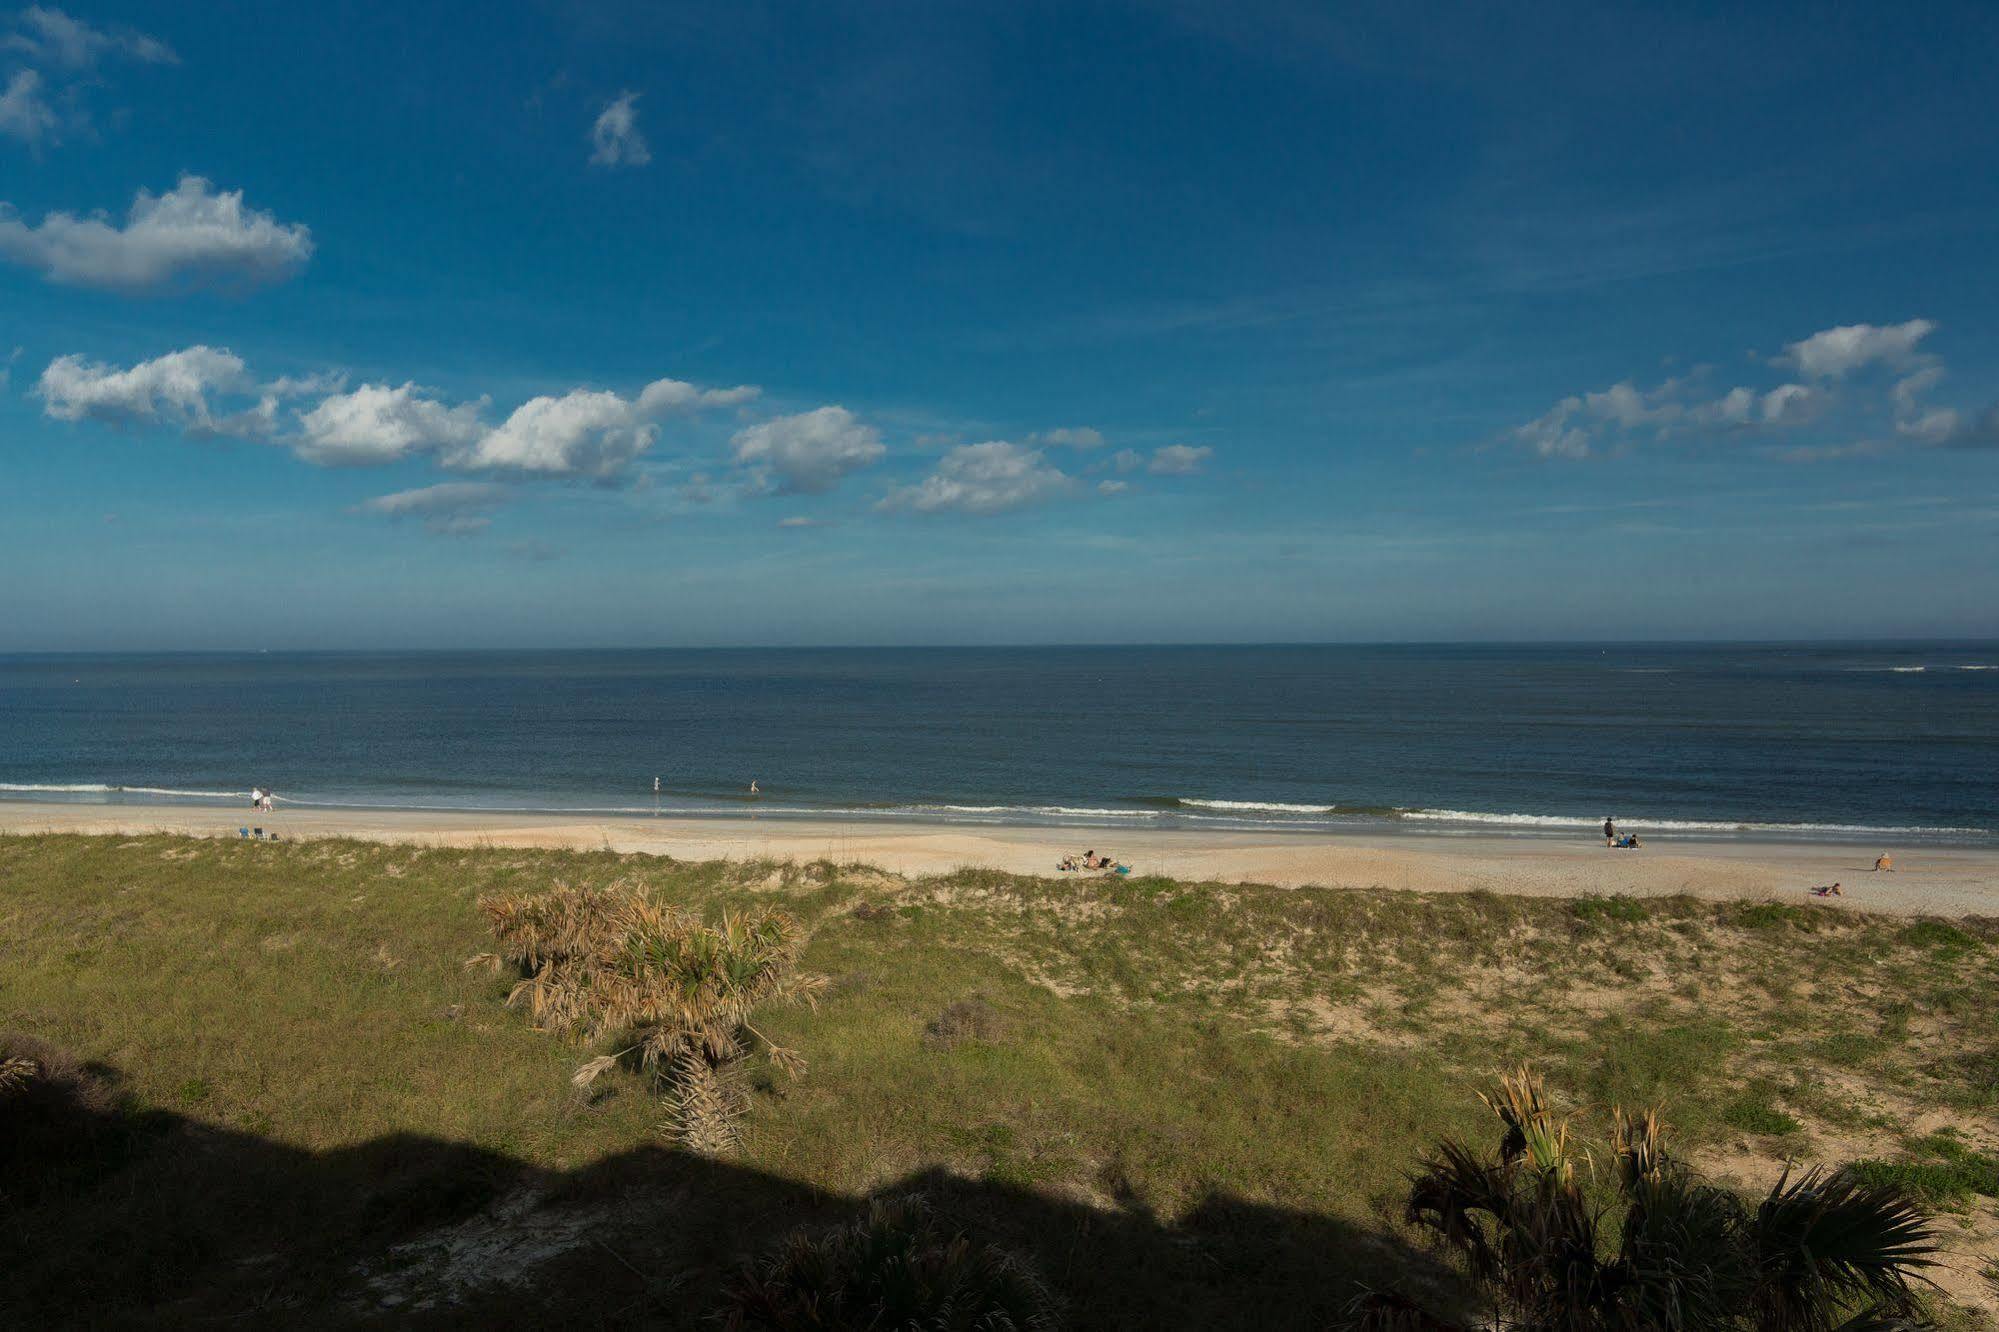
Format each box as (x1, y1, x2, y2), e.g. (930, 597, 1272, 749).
(1353, 1070, 1937, 1332)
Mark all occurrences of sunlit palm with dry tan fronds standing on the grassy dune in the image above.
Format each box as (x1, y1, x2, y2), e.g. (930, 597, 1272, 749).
(480, 888, 820, 1152)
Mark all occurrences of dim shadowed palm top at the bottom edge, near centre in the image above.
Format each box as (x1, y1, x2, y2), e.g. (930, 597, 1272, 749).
(722, 1194, 1055, 1332)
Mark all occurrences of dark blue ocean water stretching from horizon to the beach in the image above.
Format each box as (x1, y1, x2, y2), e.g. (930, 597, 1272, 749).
(0, 644, 1999, 840)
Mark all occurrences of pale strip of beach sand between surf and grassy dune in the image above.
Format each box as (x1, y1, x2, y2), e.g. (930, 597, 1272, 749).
(0, 802, 1999, 916)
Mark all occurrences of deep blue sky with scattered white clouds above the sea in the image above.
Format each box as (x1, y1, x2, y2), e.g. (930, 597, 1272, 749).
(0, 0, 1999, 650)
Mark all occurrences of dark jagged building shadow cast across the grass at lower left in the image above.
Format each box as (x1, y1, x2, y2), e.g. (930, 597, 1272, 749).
(0, 1040, 1451, 1328)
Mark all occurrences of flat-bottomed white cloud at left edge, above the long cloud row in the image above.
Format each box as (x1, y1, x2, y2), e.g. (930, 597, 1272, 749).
(0, 176, 312, 292)
